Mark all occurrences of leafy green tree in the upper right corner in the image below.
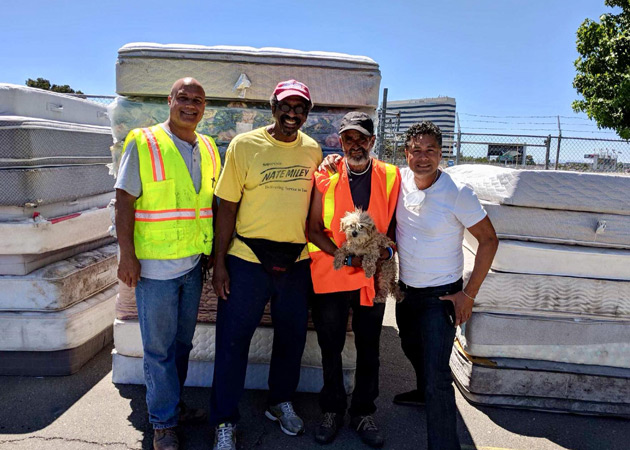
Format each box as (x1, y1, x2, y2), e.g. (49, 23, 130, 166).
(573, 0, 630, 139)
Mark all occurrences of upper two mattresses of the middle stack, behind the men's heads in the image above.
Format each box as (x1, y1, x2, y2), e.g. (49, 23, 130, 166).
(110, 43, 381, 170)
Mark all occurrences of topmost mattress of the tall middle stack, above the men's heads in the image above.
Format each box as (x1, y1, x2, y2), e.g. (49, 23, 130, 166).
(116, 42, 381, 108)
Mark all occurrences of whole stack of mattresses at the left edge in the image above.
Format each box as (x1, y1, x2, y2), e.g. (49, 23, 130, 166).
(0, 84, 116, 376)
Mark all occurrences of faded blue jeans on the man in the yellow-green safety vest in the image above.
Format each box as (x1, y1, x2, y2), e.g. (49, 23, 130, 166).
(136, 264, 201, 429)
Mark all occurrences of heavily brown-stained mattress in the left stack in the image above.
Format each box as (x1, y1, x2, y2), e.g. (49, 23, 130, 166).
(0, 244, 118, 311)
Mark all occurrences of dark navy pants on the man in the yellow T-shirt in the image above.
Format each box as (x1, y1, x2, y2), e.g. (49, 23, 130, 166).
(210, 255, 311, 426)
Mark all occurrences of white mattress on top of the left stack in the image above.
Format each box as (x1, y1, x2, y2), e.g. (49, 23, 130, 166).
(0, 83, 109, 127)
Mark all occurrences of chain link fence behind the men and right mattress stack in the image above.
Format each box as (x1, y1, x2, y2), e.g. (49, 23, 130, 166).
(377, 109, 630, 174)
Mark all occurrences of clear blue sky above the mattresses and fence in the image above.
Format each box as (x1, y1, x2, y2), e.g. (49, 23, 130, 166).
(0, 0, 614, 137)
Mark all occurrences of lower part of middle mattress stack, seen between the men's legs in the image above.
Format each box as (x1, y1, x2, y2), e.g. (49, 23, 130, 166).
(113, 283, 356, 393)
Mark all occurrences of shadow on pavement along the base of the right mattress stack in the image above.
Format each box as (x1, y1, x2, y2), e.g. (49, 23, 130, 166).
(476, 400, 630, 450)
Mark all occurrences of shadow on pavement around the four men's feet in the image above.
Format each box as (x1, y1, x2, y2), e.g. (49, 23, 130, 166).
(116, 327, 473, 450)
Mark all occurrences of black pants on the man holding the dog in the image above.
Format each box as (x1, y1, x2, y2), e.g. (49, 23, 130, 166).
(312, 291, 385, 417)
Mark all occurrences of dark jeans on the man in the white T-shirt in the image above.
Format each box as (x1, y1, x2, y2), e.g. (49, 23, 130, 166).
(396, 279, 462, 450)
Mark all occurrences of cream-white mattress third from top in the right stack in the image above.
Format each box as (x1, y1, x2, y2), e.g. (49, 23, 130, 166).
(464, 231, 630, 281)
